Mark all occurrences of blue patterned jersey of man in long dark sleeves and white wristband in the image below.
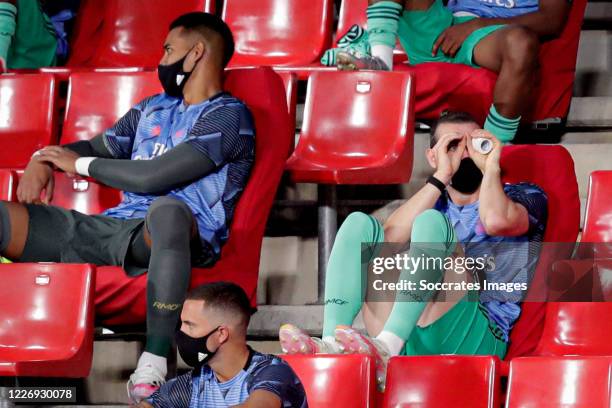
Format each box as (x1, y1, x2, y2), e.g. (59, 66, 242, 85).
(104, 93, 255, 254)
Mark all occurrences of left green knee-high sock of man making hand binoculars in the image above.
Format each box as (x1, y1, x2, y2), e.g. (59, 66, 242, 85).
(323, 212, 384, 337)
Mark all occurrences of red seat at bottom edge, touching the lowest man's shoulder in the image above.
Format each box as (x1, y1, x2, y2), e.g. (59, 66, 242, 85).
(281, 354, 376, 408)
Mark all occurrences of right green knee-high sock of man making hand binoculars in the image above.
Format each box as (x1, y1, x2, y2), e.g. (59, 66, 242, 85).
(383, 210, 457, 341)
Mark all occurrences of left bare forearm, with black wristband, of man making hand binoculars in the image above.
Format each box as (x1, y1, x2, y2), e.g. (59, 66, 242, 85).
(384, 183, 441, 243)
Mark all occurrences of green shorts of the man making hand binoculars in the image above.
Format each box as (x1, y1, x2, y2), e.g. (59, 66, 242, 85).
(400, 292, 508, 359)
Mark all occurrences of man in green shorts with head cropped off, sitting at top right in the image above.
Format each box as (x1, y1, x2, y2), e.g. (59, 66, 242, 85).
(322, 0, 571, 142)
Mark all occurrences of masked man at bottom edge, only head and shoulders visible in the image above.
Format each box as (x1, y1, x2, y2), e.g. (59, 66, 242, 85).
(138, 282, 308, 408)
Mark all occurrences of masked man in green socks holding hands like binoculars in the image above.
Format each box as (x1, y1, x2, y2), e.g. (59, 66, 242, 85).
(279, 112, 547, 388)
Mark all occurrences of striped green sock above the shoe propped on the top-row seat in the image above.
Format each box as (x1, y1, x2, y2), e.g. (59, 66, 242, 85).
(366, 1, 404, 49)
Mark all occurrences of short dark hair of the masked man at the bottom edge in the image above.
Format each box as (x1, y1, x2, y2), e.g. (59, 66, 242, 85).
(187, 282, 255, 327)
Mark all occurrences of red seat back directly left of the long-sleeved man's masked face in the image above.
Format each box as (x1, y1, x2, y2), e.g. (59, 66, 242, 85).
(60, 71, 162, 144)
